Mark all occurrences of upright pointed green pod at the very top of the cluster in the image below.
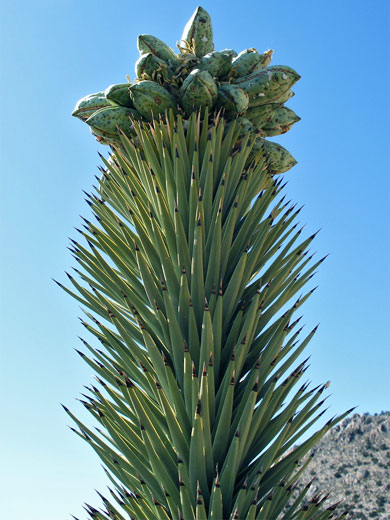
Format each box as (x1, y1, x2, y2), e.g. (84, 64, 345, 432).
(181, 6, 214, 58)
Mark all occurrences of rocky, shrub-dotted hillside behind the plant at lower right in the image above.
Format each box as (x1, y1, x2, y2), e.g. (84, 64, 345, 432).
(294, 412, 390, 520)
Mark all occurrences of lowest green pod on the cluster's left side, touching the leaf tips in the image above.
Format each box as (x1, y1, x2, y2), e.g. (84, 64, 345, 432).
(86, 106, 139, 137)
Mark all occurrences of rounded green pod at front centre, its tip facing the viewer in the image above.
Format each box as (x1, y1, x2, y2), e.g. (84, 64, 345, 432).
(179, 69, 218, 115)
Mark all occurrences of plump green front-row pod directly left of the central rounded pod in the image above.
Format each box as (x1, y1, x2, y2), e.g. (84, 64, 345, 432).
(130, 80, 177, 121)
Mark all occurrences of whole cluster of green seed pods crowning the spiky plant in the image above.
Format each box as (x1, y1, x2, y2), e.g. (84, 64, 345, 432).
(72, 7, 300, 174)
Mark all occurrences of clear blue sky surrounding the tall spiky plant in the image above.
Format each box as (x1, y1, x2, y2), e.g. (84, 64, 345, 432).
(0, 0, 390, 520)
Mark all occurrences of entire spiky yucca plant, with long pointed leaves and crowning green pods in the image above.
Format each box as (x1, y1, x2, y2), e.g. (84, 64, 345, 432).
(58, 7, 354, 520)
